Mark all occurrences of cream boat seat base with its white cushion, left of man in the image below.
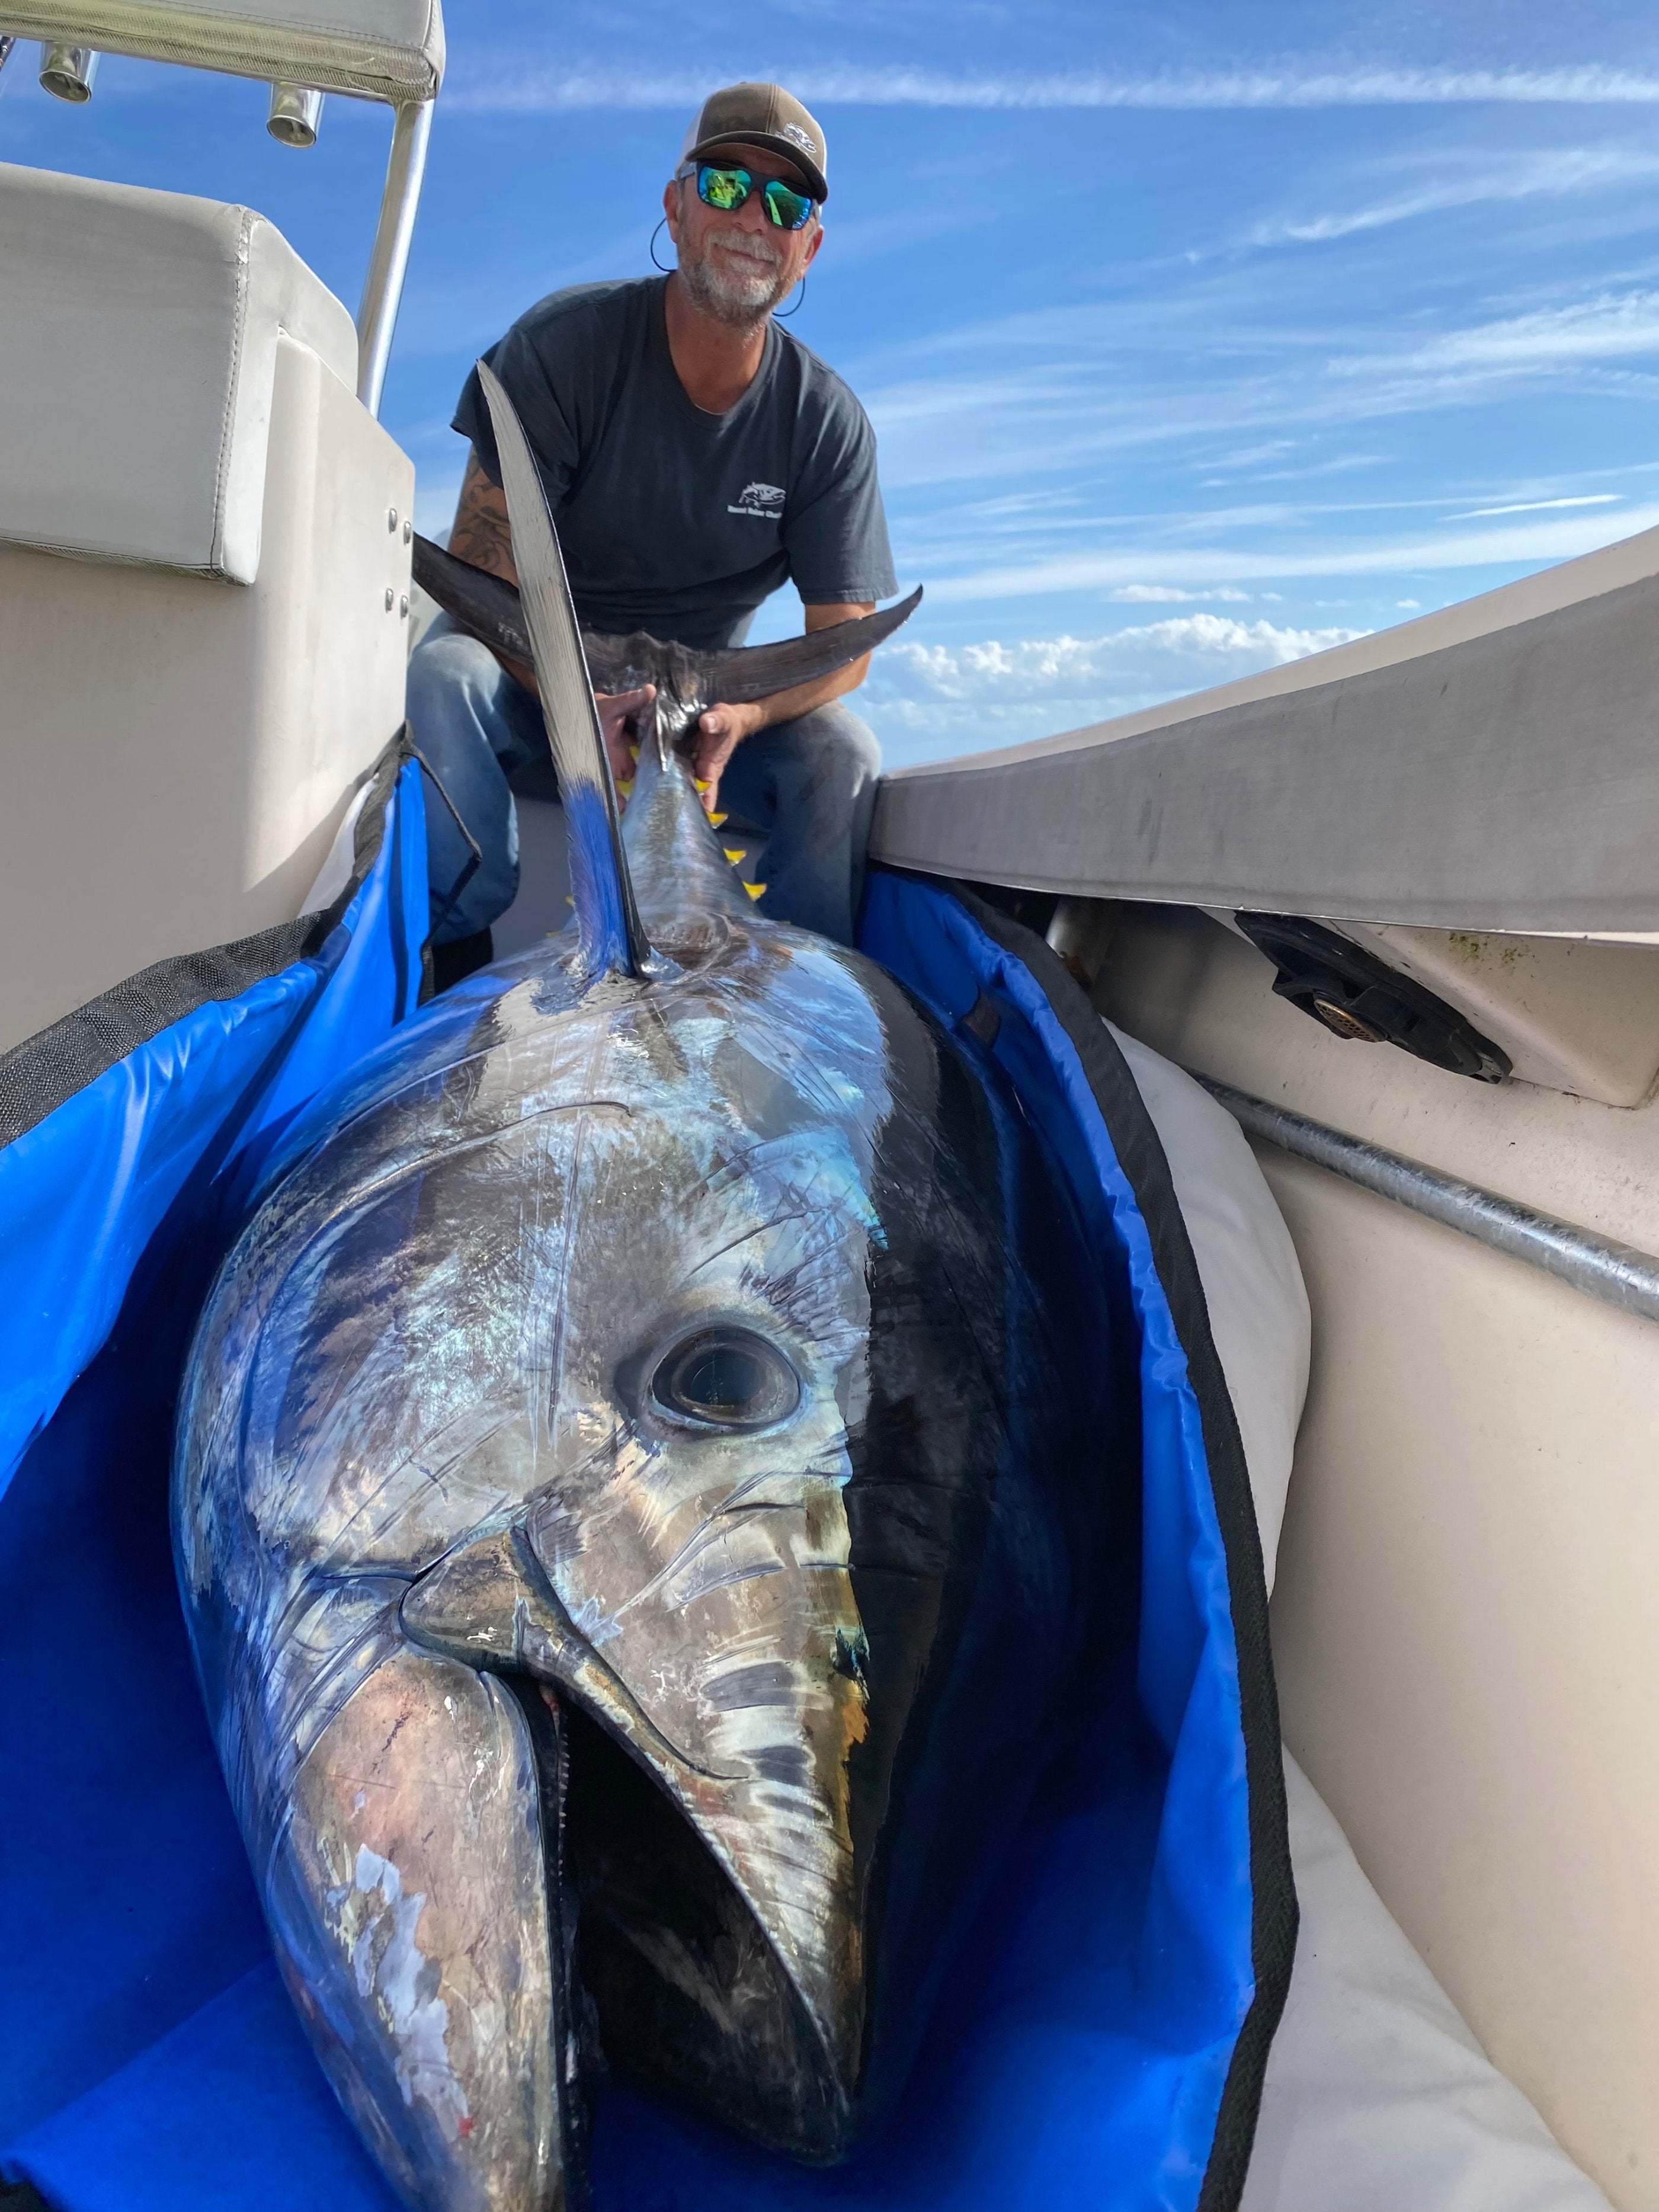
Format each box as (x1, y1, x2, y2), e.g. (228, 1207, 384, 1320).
(0, 166, 414, 1048)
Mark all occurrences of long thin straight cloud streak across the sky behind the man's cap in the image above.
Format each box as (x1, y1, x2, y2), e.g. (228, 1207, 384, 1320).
(444, 51, 1659, 115)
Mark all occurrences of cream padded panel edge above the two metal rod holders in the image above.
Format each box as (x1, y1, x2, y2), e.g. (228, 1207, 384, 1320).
(4, 0, 444, 104)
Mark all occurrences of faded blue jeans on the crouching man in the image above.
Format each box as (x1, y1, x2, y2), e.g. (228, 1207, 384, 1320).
(409, 615, 880, 945)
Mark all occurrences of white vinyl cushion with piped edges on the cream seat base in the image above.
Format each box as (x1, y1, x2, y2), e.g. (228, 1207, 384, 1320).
(0, 164, 356, 584)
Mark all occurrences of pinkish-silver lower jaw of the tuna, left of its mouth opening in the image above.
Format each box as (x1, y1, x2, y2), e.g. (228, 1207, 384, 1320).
(268, 1650, 579, 2212)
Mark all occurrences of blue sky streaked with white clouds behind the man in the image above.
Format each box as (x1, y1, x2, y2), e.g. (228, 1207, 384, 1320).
(0, 0, 1659, 761)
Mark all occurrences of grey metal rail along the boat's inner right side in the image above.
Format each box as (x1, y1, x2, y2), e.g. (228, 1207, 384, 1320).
(1194, 1071, 1659, 1321)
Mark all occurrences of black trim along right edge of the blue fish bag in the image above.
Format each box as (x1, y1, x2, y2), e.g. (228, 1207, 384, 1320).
(942, 878, 1296, 2212)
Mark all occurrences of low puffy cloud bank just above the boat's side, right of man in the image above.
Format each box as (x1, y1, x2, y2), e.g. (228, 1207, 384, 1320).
(872, 615, 1367, 703)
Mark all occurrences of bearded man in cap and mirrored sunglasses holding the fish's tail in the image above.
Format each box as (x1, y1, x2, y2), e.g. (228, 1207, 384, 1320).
(409, 84, 898, 978)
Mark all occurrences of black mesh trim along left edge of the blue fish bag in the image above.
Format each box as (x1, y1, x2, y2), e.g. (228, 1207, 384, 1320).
(0, 730, 414, 1146)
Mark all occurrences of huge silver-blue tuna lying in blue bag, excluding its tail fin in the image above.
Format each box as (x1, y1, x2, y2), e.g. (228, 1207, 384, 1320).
(175, 378, 1128, 2212)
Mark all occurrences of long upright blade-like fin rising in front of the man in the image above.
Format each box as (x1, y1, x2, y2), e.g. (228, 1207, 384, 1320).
(478, 360, 652, 975)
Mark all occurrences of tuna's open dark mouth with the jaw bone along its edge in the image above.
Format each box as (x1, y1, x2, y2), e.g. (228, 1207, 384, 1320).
(401, 1526, 863, 2163)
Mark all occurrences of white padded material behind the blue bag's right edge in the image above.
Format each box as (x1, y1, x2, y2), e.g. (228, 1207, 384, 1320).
(1108, 1024, 1608, 2212)
